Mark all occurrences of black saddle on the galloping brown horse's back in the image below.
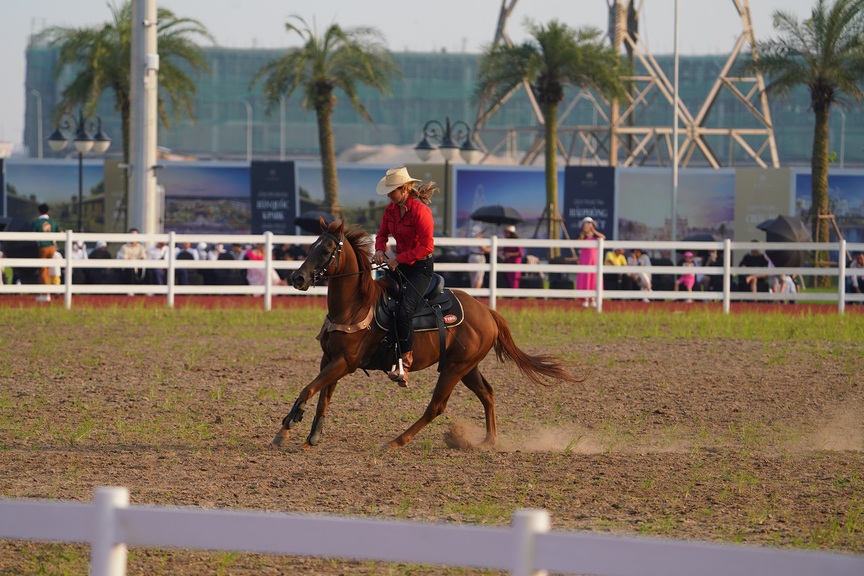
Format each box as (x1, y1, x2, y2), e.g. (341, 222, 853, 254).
(373, 274, 465, 372)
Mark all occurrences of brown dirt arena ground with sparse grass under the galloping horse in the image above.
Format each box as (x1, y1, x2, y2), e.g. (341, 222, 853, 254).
(0, 297, 864, 575)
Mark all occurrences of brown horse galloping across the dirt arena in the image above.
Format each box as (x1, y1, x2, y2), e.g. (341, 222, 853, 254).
(273, 219, 578, 448)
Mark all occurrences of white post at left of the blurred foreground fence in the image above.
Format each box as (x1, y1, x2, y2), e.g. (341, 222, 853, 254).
(90, 488, 129, 576)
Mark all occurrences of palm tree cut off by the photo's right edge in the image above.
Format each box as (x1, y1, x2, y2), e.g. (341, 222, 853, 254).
(747, 0, 864, 242)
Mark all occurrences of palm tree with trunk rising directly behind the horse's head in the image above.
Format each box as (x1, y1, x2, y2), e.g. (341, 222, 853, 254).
(250, 16, 400, 216)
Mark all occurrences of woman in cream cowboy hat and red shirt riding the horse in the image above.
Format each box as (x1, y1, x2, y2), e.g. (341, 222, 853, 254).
(372, 167, 438, 387)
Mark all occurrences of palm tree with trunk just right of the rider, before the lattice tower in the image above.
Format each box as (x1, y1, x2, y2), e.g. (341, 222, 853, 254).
(478, 20, 626, 243)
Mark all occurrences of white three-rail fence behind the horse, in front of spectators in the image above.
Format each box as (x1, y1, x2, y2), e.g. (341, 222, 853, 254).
(0, 231, 864, 314)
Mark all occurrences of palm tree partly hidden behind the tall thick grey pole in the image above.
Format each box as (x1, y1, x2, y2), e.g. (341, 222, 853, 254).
(39, 1, 213, 162)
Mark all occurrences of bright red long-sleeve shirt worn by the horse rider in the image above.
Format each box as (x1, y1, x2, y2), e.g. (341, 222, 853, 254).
(375, 196, 435, 264)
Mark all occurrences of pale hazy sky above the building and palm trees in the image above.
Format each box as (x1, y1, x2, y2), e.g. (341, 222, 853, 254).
(0, 0, 816, 152)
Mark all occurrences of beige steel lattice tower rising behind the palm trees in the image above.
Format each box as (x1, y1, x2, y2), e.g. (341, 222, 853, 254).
(476, 0, 780, 168)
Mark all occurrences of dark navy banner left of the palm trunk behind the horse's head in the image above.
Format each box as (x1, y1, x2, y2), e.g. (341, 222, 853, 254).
(250, 161, 297, 234)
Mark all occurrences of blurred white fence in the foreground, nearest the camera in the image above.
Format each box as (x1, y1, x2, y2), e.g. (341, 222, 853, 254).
(0, 488, 864, 576)
